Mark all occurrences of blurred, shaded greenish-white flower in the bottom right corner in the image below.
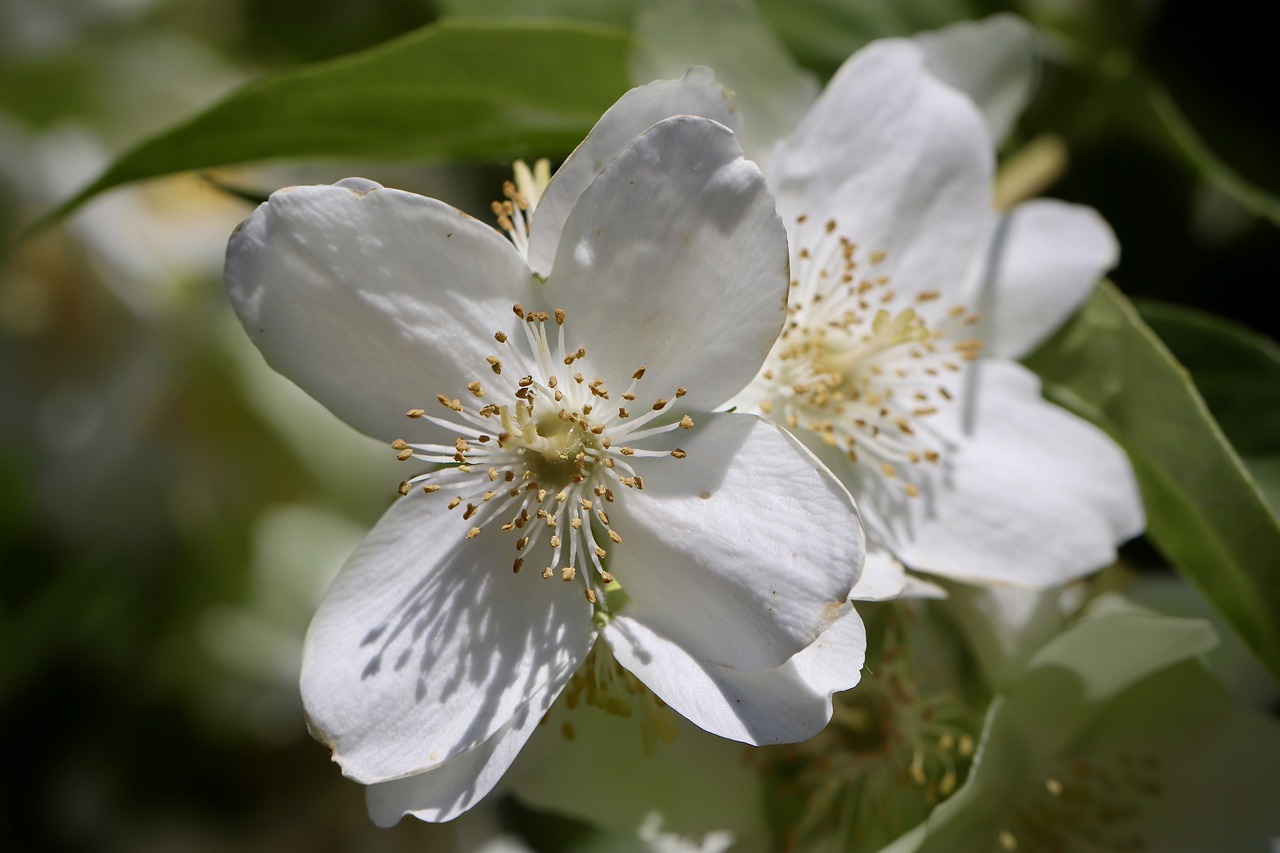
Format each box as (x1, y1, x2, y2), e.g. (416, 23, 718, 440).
(884, 597, 1280, 853)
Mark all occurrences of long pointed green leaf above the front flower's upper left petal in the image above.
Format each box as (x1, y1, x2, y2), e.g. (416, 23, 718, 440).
(33, 20, 630, 229)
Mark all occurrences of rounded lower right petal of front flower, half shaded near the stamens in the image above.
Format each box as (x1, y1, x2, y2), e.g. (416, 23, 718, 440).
(599, 415, 863, 671)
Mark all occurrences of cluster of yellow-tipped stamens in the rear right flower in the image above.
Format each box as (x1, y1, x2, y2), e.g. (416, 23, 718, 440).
(760, 215, 980, 497)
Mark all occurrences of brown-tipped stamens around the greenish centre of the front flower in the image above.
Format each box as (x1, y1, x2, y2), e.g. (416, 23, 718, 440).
(392, 305, 694, 607)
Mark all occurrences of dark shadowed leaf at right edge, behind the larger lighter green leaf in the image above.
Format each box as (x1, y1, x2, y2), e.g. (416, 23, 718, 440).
(1137, 300, 1280, 514)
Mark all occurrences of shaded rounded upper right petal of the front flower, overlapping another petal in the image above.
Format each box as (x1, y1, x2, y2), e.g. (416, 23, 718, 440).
(545, 115, 787, 410)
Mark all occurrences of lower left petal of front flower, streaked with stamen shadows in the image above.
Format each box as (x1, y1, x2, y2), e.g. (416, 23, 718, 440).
(302, 492, 594, 783)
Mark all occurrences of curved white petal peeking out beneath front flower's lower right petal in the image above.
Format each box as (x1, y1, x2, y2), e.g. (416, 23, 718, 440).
(604, 596, 867, 744)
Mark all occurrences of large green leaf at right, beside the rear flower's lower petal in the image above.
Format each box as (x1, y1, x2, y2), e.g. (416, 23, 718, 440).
(1027, 284, 1280, 678)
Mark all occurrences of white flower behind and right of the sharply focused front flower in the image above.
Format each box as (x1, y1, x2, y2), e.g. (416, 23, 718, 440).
(733, 19, 1143, 587)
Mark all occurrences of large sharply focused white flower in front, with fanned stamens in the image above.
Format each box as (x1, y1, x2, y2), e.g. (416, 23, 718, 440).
(227, 73, 863, 822)
